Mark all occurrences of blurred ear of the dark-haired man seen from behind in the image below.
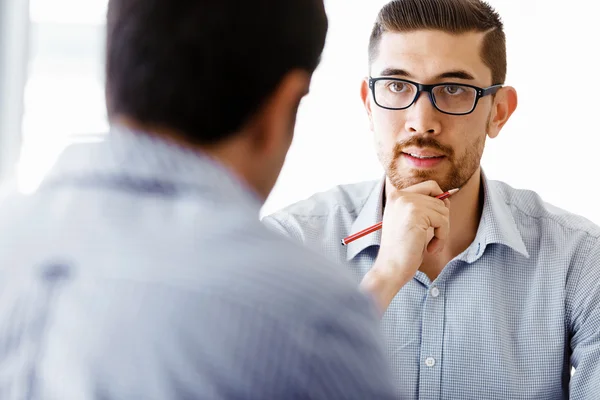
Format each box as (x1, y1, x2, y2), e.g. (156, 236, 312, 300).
(249, 69, 311, 154)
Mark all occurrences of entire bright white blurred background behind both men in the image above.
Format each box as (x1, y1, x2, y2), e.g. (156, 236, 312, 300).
(0, 0, 600, 223)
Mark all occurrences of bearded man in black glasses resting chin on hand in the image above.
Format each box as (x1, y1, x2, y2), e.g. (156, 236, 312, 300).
(265, 0, 600, 400)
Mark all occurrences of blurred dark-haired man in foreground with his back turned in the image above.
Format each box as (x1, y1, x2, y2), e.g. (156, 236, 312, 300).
(0, 0, 392, 400)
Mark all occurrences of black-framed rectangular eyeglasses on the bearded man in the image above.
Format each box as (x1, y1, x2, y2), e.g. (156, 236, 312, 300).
(369, 77, 502, 115)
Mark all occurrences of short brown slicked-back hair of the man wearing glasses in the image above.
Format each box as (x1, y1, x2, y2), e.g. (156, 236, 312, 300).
(369, 0, 506, 85)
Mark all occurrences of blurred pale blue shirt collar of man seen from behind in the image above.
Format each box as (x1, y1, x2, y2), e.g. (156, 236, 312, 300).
(42, 125, 262, 213)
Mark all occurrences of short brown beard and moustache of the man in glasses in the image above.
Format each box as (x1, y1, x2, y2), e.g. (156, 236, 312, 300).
(379, 134, 486, 192)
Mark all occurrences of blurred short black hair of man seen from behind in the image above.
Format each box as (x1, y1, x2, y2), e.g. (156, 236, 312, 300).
(106, 0, 327, 145)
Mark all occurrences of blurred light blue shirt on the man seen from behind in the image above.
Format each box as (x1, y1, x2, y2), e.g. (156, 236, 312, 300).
(0, 129, 393, 400)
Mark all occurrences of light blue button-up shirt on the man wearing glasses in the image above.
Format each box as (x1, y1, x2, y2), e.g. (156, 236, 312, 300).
(264, 176, 600, 400)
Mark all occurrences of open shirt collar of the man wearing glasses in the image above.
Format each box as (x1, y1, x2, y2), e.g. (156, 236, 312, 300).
(346, 171, 529, 262)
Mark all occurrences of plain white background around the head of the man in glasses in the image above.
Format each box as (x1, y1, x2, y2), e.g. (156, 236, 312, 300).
(263, 0, 600, 223)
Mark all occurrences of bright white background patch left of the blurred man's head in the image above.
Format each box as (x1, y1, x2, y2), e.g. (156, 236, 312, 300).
(16, 0, 108, 192)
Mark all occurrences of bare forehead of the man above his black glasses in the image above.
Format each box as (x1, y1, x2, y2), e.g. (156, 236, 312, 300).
(371, 30, 492, 85)
